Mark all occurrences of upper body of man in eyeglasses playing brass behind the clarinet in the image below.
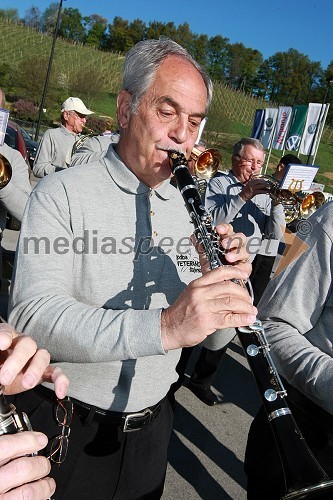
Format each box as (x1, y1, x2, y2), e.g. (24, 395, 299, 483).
(206, 137, 285, 261)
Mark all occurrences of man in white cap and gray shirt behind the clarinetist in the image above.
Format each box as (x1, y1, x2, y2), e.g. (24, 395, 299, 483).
(33, 97, 93, 177)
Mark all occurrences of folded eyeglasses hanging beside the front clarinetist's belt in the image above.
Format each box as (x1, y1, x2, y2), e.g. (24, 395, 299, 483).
(47, 398, 73, 465)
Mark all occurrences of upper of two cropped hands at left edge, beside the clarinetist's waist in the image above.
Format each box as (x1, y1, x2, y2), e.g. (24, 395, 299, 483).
(0, 323, 69, 399)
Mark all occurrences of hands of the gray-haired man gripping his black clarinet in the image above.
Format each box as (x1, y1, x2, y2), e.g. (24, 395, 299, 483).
(161, 224, 257, 351)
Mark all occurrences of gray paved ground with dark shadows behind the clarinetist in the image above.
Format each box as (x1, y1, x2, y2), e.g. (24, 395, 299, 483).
(0, 230, 259, 500)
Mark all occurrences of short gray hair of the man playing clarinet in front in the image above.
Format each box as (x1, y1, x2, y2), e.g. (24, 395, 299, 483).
(122, 37, 213, 113)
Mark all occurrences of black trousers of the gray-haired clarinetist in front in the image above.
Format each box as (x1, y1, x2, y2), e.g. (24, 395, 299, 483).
(10, 391, 173, 500)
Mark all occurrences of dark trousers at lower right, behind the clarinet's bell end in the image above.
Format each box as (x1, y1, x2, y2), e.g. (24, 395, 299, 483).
(244, 388, 333, 500)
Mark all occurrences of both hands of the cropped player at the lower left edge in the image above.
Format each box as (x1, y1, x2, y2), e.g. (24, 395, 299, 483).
(0, 323, 69, 500)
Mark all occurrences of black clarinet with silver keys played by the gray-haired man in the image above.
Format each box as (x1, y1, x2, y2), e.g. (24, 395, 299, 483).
(168, 151, 333, 500)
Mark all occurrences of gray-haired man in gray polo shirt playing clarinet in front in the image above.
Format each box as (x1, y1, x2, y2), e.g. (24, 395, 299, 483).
(10, 38, 257, 500)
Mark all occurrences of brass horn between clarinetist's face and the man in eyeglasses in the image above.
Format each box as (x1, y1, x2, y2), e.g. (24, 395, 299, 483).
(189, 147, 222, 197)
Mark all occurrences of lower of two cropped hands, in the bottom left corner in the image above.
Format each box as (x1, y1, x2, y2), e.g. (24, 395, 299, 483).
(0, 431, 55, 500)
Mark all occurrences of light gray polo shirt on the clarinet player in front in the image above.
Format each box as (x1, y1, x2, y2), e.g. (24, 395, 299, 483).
(10, 146, 233, 411)
